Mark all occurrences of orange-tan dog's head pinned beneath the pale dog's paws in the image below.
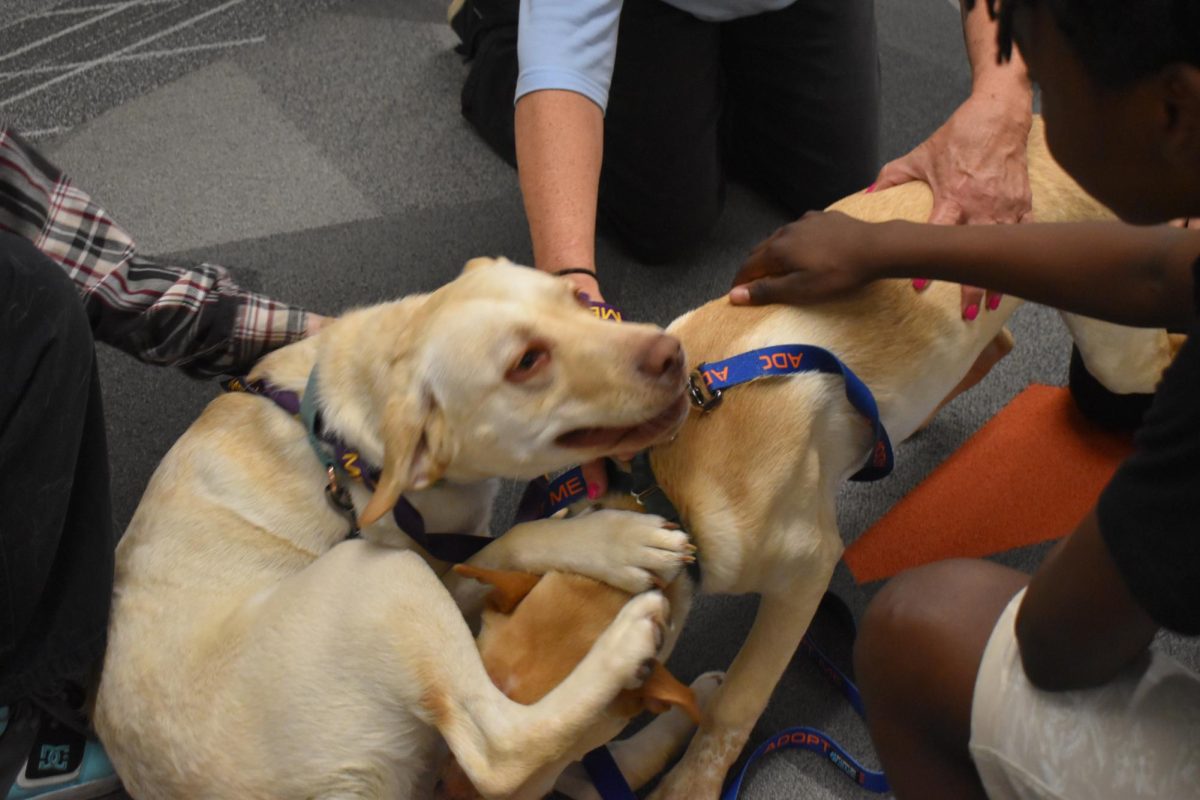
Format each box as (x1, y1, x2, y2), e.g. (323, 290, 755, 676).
(438, 565, 700, 800)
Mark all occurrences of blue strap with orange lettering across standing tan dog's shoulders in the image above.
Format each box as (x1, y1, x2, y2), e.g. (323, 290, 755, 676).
(690, 344, 894, 481)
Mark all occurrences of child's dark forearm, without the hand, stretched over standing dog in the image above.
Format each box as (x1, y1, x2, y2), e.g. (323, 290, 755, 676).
(871, 222, 1200, 327)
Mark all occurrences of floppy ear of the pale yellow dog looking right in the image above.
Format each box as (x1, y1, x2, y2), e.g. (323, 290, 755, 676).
(359, 396, 449, 528)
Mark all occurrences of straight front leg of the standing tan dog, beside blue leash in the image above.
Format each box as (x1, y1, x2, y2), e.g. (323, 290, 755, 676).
(652, 542, 841, 800)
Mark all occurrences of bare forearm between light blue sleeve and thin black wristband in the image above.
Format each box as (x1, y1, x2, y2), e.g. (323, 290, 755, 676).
(516, 90, 604, 284)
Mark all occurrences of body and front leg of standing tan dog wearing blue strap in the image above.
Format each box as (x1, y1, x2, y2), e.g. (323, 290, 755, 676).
(549, 121, 1177, 800)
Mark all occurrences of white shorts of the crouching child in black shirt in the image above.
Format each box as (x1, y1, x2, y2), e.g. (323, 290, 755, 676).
(971, 590, 1200, 800)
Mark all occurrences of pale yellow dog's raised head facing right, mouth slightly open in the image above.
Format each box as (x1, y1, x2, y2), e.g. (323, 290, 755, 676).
(318, 259, 688, 524)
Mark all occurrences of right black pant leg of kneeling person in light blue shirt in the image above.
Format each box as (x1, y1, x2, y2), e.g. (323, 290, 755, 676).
(721, 0, 880, 216)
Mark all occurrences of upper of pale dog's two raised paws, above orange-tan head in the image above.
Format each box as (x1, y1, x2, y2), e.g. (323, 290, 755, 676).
(576, 510, 696, 594)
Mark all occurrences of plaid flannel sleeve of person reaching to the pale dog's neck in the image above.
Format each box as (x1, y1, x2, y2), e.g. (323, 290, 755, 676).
(0, 127, 307, 377)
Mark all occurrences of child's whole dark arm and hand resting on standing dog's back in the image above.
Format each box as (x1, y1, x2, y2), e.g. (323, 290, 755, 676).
(730, 212, 1200, 327)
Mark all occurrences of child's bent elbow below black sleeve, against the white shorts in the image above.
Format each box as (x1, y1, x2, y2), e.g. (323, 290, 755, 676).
(1016, 512, 1158, 691)
